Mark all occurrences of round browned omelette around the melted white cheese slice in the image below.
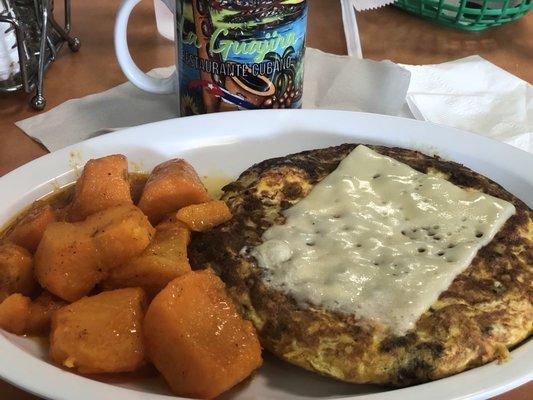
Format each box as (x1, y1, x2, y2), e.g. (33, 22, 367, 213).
(189, 144, 533, 386)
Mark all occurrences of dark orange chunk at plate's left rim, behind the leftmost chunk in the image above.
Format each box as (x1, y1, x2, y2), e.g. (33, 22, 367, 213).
(8, 202, 56, 253)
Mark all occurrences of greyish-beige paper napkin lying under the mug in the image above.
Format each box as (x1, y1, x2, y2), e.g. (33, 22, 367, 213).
(17, 48, 410, 151)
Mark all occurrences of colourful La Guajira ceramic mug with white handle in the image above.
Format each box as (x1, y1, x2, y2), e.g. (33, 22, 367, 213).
(115, 0, 307, 116)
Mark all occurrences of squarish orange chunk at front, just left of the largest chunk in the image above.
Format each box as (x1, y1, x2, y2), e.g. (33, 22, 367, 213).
(50, 288, 146, 374)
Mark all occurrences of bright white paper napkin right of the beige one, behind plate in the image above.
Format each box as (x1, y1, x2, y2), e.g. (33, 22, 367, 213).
(404, 56, 533, 152)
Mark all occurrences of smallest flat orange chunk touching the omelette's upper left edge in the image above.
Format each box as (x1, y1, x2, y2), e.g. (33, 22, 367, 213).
(176, 200, 232, 232)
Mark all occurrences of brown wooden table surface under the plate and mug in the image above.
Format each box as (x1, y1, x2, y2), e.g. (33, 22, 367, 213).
(0, 0, 533, 400)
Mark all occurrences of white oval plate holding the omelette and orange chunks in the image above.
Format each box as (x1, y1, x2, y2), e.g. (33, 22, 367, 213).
(0, 110, 533, 400)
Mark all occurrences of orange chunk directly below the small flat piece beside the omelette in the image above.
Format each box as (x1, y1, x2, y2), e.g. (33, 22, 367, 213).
(103, 222, 191, 297)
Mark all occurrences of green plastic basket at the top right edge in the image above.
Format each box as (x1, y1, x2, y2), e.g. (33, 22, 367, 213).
(394, 0, 533, 31)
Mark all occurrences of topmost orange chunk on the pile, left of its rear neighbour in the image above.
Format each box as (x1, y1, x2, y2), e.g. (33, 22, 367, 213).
(68, 154, 133, 221)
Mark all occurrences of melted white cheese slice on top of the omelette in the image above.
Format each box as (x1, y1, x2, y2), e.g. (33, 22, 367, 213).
(251, 145, 515, 334)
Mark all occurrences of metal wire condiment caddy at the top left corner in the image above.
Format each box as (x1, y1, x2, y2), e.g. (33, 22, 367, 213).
(0, 0, 80, 110)
